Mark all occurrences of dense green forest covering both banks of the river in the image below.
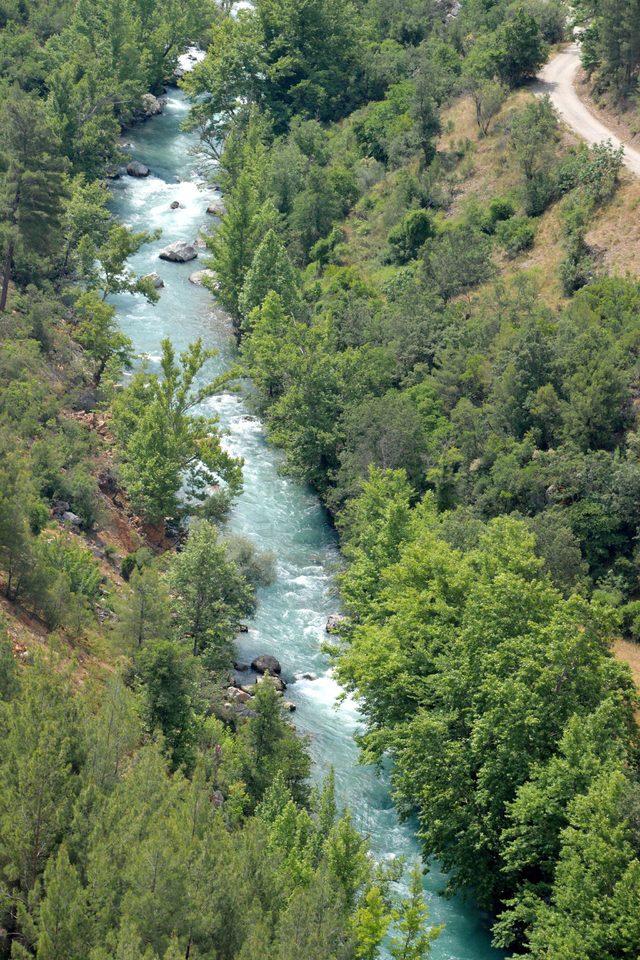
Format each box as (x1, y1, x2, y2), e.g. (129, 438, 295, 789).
(0, 0, 640, 960)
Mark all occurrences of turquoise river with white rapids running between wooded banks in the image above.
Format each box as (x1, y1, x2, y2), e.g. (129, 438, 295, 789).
(112, 77, 502, 960)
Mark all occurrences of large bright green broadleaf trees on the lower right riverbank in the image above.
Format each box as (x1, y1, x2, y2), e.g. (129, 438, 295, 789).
(337, 498, 636, 956)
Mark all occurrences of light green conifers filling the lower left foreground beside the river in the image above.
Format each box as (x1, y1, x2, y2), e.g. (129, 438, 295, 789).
(0, 641, 430, 960)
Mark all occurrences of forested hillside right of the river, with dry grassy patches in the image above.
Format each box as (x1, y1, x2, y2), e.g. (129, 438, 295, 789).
(186, 0, 640, 960)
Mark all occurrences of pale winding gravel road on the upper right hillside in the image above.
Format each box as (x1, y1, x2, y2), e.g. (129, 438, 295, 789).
(536, 43, 640, 177)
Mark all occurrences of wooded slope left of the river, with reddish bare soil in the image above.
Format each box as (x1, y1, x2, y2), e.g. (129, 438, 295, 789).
(0, 0, 438, 960)
